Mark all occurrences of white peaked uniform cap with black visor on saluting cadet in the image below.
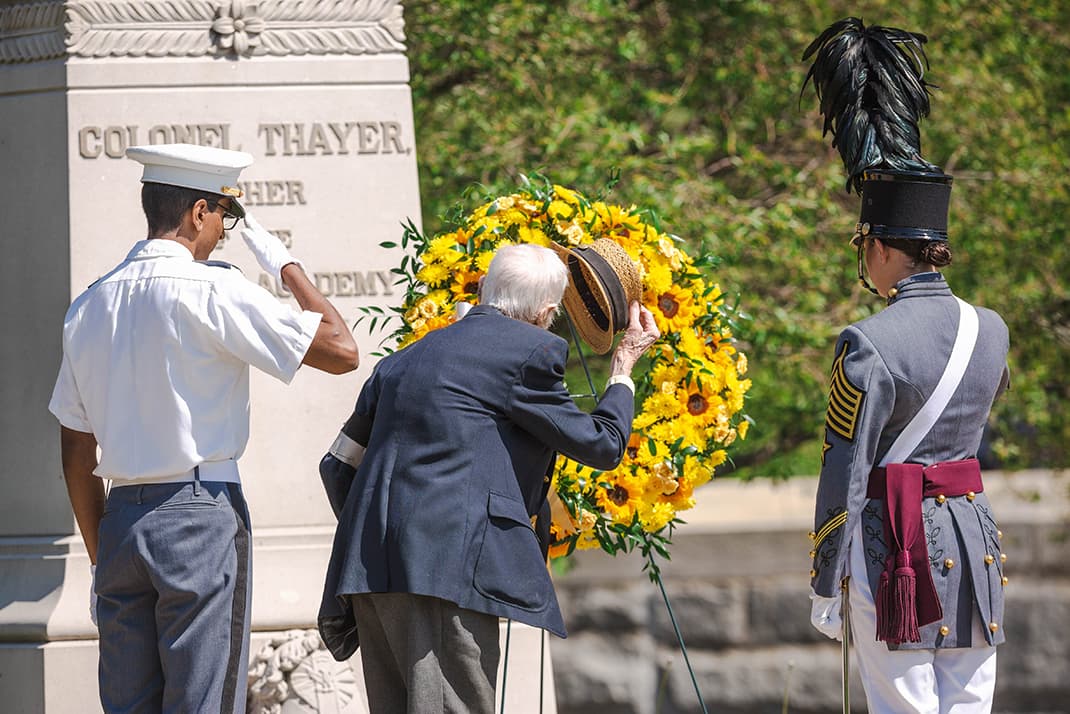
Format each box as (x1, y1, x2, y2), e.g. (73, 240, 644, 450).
(126, 143, 253, 214)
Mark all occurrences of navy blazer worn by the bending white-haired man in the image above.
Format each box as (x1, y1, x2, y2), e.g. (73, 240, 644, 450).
(319, 305, 635, 659)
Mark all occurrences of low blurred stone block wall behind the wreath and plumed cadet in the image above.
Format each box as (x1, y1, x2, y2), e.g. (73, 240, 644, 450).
(551, 471, 1070, 714)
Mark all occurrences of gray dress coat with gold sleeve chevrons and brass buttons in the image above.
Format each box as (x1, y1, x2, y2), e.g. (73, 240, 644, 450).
(811, 273, 1009, 649)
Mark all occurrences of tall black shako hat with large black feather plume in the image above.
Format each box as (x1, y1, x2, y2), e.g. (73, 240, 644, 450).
(803, 17, 951, 242)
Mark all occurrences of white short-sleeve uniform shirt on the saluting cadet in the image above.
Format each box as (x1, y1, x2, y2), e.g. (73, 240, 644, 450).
(48, 239, 322, 480)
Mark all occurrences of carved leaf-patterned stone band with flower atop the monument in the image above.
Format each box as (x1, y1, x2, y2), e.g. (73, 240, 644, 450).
(0, 0, 406, 63)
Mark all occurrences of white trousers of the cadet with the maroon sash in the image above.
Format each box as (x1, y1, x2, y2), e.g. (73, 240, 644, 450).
(850, 525, 996, 714)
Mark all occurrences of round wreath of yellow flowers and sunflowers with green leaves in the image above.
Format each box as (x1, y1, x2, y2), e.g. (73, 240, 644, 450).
(358, 177, 750, 577)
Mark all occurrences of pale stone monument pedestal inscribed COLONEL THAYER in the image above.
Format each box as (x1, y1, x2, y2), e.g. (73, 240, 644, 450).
(0, 0, 552, 714)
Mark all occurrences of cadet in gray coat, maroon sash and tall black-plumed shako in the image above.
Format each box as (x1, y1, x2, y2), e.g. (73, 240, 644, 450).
(805, 18, 1009, 712)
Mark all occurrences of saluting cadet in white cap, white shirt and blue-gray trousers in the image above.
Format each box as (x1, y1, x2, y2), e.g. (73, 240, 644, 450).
(49, 145, 357, 714)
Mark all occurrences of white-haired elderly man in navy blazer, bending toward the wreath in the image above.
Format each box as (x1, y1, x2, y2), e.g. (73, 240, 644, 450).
(319, 245, 658, 714)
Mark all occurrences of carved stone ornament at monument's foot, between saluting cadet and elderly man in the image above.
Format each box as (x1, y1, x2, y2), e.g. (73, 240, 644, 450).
(246, 629, 356, 714)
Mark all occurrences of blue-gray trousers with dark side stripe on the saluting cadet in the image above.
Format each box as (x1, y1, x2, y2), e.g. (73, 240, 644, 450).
(96, 482, 251, 714)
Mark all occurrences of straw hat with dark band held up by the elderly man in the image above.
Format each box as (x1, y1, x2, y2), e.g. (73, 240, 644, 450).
(552, 238, 643, 354)
